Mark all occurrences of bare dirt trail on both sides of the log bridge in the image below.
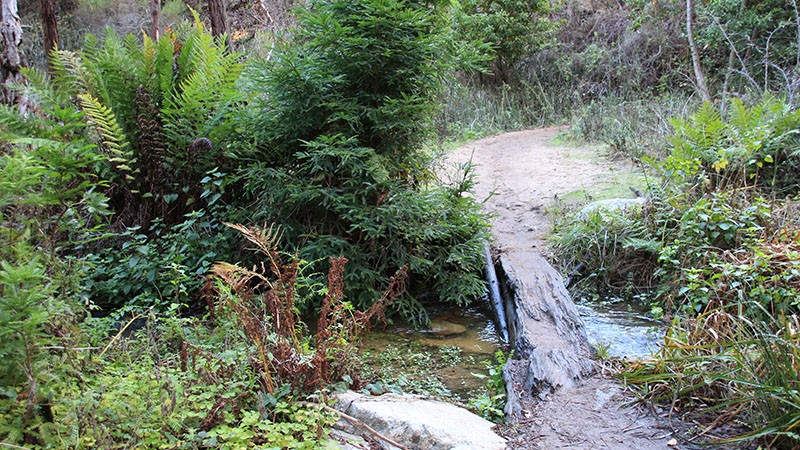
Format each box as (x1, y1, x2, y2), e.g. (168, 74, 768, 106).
(451, 128, 689, 450)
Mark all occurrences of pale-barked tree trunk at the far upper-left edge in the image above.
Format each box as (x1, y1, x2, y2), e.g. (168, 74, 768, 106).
(0, 0, 26, 105)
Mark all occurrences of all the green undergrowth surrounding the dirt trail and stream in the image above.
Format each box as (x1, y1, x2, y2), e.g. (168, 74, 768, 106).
(0, 0, 800, 448)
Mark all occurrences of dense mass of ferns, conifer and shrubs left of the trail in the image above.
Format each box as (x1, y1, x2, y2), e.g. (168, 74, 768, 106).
(0, 2, 494, 448)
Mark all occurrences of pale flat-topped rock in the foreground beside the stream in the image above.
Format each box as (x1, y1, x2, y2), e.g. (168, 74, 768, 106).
(335, 391, 506, 450)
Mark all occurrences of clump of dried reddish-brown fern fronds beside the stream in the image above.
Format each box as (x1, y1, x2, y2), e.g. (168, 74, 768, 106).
(209, 223, 408, 393)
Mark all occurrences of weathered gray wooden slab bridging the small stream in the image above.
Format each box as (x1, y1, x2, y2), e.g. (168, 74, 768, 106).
(499, 250, 593, 422)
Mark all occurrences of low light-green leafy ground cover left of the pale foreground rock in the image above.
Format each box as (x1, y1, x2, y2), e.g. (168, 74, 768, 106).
(0, 314, 336, 449)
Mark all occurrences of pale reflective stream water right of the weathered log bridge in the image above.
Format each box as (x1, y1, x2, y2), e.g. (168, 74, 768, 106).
(577, 301, 664, 358)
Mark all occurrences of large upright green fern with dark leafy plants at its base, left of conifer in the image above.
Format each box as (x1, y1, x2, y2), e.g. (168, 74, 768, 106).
(0, 17, 243, 312)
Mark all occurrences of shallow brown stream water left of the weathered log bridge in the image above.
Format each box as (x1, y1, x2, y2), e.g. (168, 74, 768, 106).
(362, 307, 508, 401)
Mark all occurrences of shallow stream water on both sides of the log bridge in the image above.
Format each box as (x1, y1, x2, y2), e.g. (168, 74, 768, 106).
(362, 302, 662, 401)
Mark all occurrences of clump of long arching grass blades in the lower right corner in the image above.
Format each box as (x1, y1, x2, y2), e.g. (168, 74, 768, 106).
(620, 303, 800, 448)
